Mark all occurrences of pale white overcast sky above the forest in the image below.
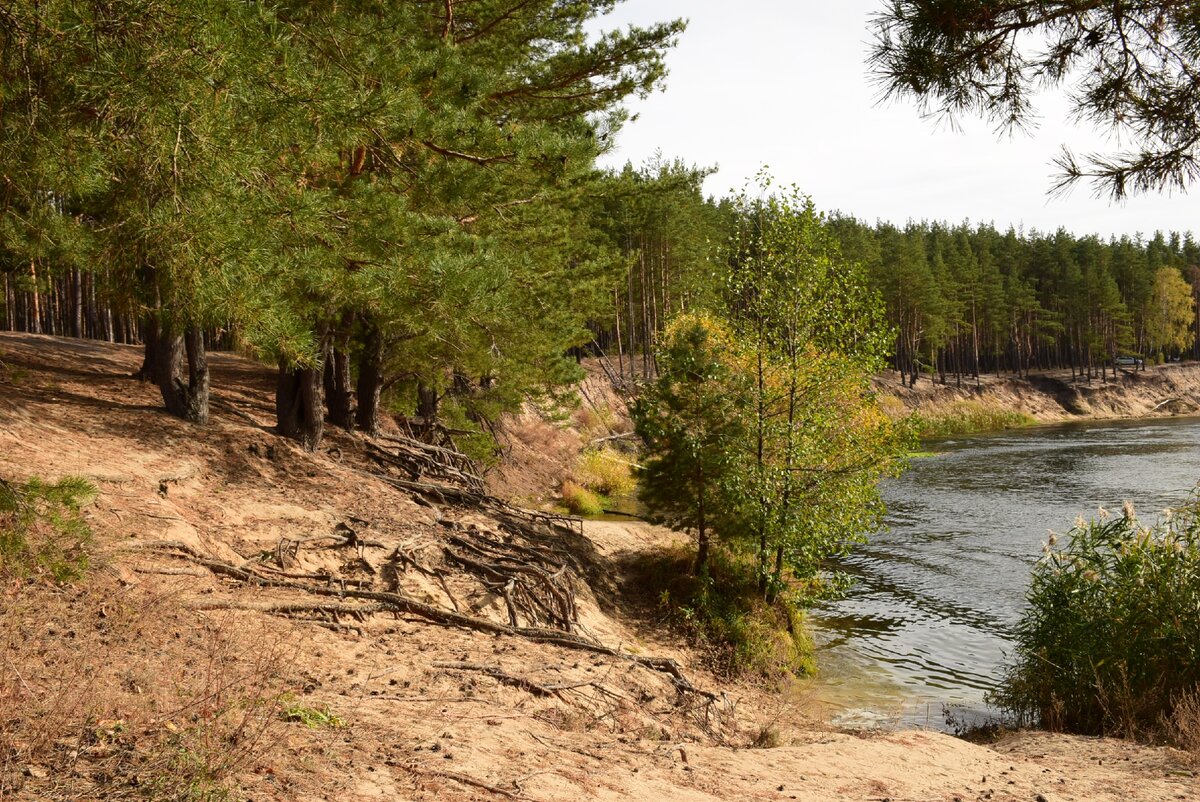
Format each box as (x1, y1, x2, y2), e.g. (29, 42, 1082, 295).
(601, 0, 1200, 239)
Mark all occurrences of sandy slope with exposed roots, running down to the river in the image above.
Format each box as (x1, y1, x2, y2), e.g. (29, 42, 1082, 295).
(0, 335, 1200, 802)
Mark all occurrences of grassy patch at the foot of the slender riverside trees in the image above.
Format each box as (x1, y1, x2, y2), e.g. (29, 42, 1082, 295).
(629, 546, 816, 680)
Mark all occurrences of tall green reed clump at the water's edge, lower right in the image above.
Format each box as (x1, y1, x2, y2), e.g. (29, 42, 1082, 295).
(992, 498, 1200, 738)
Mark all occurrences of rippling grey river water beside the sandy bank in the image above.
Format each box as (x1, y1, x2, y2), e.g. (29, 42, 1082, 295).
(811, 418, 1200, 729)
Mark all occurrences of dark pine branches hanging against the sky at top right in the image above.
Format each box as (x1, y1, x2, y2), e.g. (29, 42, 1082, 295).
(870, 0, 1200, 198)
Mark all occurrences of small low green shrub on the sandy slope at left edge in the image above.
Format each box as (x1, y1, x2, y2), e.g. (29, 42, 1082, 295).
(0, 477, 96, 583)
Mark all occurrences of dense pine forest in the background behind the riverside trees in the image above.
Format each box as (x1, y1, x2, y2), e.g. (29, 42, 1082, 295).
(593, 162, 1200, 383)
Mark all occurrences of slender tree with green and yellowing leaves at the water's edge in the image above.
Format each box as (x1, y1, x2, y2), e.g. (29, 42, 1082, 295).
(725, 178, 900, 597)
